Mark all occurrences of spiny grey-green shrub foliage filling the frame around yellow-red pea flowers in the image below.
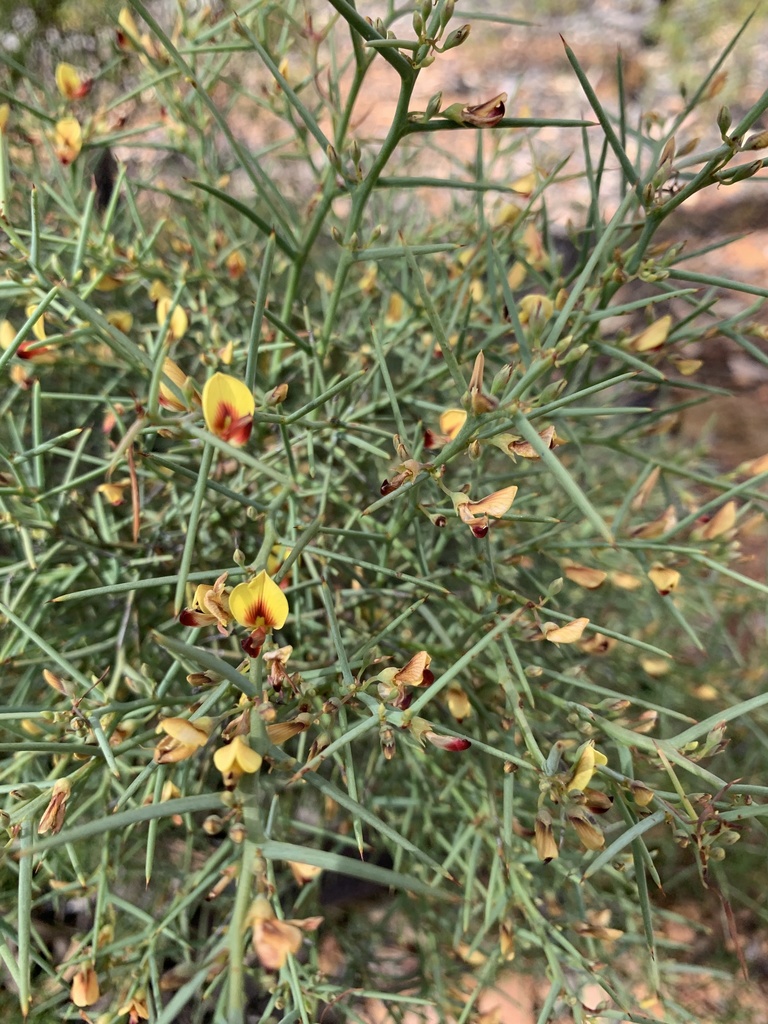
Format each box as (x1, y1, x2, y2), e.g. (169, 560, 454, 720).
(0, 0, 768, 1024)
